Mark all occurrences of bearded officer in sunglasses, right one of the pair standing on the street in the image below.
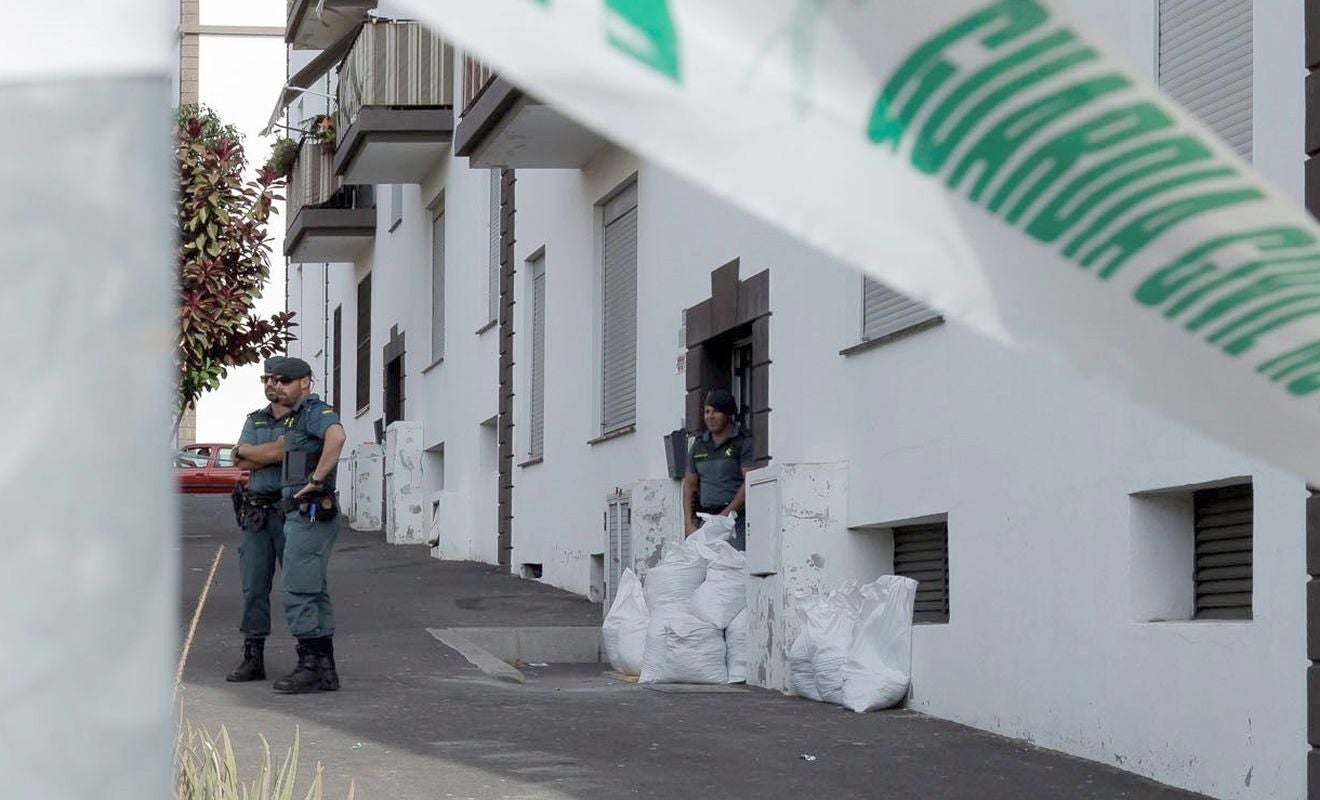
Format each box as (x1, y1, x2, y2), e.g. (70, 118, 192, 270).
(253, 358, 346, 694)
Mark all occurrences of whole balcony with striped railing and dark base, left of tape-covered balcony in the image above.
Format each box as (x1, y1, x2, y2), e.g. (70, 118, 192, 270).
(334, 22, 454, 183)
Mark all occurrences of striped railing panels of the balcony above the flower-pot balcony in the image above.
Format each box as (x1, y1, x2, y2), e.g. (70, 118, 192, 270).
(335, 22, 454, 140)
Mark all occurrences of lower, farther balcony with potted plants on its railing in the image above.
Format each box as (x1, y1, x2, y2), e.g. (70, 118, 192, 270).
(284, 139, 376, 263)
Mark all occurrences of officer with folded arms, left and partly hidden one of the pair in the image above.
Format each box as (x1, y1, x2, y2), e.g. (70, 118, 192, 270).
(224, 356, 297, 681)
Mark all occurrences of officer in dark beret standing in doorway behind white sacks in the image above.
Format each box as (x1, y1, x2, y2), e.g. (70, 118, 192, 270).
(682, 389, 754, 550)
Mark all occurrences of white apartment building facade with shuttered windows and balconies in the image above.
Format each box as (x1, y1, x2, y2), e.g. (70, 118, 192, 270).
(281, 0, 1320, 797)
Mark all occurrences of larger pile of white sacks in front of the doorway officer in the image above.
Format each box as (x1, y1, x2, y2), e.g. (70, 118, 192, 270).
(601, 515, 747, 684)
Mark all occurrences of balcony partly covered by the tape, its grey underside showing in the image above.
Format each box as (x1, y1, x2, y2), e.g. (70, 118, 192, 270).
(454, 55, 605, 169)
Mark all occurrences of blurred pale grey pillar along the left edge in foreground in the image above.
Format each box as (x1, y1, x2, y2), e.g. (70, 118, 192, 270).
(0, 0, 178, 800)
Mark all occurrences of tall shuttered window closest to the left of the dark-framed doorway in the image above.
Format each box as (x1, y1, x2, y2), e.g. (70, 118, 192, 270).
(601, 183, 638, 433)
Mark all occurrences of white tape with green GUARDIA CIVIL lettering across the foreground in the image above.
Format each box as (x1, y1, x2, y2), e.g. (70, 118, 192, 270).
(401, 0, 1320, 481)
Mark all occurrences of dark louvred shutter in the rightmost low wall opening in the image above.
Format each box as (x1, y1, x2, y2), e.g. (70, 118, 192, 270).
(1192, 484, 1253, 619)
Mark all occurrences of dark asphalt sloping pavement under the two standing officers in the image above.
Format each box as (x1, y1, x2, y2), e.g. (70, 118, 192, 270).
(180, 496, 1199, 800)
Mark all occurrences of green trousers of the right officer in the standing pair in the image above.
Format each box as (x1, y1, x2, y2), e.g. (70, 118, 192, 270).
(282, 510, 339, 639)
